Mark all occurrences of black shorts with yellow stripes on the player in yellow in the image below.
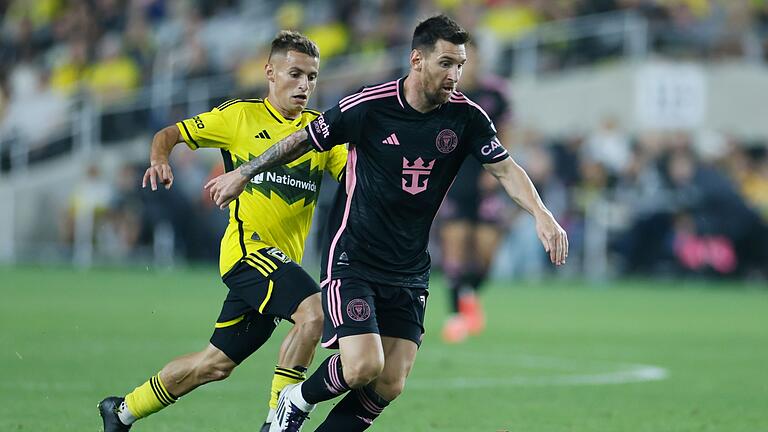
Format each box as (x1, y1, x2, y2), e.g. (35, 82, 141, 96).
(211, 248, 320, 364)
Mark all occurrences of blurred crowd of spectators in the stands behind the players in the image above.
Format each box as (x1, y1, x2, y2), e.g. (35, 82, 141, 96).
(0, 0, 768, 276)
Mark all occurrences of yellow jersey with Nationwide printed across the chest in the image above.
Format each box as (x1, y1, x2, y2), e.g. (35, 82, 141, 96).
(176, 99, 347, 275)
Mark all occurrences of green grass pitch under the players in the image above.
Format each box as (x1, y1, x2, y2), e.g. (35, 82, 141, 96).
(0, 267, 768, 432)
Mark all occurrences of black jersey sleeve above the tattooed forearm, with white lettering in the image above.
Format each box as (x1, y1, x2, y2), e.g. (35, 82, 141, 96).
(306, 100, 362, 152)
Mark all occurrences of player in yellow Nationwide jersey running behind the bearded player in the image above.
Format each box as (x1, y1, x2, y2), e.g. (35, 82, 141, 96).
(99, 31, 347, 432)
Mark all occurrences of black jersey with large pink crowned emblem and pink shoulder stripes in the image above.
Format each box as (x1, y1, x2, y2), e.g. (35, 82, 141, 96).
(306, 78, 509, 287)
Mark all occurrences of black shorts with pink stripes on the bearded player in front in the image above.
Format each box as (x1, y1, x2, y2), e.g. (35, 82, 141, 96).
(322, 278, 429, 348)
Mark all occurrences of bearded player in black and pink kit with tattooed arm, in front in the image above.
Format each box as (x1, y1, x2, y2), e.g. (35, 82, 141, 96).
(205, 15, 568, 432)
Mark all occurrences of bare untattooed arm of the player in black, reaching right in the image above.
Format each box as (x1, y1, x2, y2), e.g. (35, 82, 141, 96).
(484, 158, 568, 265)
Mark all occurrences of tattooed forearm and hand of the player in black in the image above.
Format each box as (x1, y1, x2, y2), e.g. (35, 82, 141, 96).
(205, 129, 312, 209)
